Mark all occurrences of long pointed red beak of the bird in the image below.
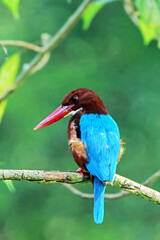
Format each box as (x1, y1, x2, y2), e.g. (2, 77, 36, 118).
(34, 105, 72, 130)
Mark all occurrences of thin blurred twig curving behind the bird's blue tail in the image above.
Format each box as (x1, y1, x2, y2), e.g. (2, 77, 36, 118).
(62, 171, 160, 200)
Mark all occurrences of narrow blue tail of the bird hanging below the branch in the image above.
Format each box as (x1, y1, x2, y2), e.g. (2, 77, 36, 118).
(93, 177, 106, 224)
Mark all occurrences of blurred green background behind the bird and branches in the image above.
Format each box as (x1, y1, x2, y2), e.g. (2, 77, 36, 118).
(0, 0, 160, 240)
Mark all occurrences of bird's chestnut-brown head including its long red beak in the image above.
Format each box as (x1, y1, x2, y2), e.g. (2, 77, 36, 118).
(34, 88, 108, 130)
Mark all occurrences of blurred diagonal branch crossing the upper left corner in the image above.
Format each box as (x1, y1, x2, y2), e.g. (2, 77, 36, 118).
(0, 0, 93, 102)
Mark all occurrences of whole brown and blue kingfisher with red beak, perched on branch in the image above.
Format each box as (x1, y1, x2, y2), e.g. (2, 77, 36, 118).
(34, 88, 124, 224)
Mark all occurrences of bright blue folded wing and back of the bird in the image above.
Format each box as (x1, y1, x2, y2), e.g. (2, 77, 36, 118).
(80, 114, 120, 182)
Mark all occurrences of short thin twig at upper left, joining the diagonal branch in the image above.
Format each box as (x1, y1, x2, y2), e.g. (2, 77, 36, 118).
(0, 40, 42, 52)
